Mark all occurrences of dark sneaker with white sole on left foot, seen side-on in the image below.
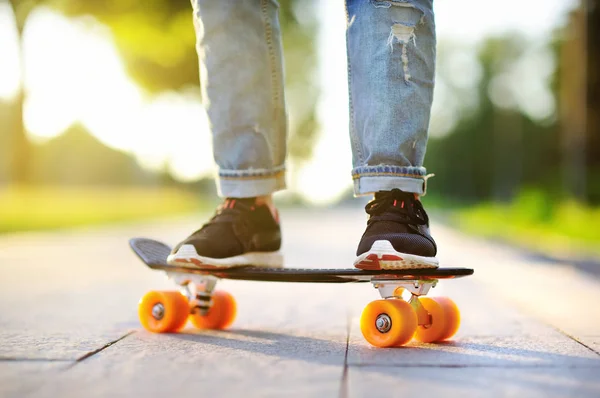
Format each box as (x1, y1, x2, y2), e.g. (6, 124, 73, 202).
(167, 198, 283, 268)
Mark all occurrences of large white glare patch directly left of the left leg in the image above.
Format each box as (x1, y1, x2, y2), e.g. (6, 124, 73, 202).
(14, 7, 214, 181)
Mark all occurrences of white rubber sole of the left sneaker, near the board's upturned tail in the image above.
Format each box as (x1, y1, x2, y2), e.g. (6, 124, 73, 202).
(167, 245, 283, 269)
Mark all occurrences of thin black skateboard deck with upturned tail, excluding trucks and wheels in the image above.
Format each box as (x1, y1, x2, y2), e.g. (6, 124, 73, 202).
(129, 238, 473, 283)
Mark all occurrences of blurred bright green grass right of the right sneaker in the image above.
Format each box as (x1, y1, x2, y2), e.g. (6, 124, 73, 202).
(451, 191, 600, 256)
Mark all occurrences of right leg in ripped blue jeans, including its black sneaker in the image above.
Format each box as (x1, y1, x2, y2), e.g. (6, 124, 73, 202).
(346, 0, 438, 269)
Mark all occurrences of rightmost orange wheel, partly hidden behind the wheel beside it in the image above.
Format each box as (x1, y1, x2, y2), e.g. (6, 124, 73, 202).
(415, 297, 460, 343)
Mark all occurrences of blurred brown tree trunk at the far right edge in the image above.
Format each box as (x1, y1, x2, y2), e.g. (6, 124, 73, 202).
(559, 0, 600, 204)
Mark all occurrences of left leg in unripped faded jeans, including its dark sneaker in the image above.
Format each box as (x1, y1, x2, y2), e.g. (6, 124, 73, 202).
(169, 0, 287, 268)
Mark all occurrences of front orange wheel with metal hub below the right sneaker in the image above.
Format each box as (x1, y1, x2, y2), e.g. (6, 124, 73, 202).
(360, 299, 417, 347)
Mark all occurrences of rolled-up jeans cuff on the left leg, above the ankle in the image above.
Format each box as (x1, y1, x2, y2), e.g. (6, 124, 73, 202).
(217, 170, 286, 198)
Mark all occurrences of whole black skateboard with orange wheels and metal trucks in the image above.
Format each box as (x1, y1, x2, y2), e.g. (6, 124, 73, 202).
(129, 238, 473, 347)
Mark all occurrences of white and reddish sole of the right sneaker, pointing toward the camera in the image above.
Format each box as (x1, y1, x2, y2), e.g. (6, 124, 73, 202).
(354, 240, 439, 270)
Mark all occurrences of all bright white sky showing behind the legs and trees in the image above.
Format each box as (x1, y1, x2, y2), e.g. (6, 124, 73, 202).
(0, 0, 575, 202)
